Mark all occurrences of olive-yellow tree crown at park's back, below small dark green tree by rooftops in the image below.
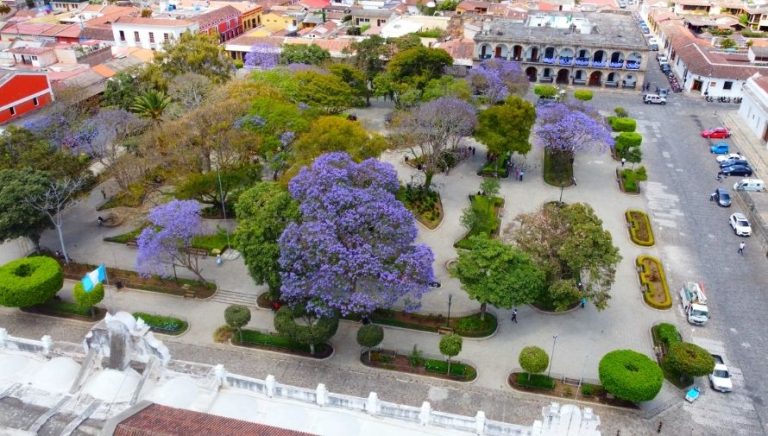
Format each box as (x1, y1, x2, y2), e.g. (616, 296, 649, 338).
(295, 71, 355, 114)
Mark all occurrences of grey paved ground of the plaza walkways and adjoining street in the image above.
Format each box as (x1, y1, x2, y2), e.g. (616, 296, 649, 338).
(1, 89, 768, 435)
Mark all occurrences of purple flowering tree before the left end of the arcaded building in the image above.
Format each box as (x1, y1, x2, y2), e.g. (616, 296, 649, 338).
(467, 59, 529, 103)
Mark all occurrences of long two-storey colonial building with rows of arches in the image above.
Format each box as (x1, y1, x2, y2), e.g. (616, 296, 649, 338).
(474, 11, 651, 90)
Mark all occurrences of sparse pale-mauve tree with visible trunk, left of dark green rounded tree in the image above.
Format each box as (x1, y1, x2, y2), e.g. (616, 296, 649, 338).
(393, 97, 477, 190)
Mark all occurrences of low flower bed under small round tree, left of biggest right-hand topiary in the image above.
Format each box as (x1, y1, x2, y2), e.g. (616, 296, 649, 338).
(507, 372, 637, 409)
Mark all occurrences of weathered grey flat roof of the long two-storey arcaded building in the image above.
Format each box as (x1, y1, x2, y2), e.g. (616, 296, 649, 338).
(475, 11, 648, 50)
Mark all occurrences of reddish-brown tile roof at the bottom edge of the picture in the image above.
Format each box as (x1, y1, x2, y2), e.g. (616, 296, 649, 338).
(113, 404, 312, 436)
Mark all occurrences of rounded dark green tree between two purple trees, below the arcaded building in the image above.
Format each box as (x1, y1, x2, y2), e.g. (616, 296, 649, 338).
(475, 95, 536, 156)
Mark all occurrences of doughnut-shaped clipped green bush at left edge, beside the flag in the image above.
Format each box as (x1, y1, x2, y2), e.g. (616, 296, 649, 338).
(0, 256, 64, 307)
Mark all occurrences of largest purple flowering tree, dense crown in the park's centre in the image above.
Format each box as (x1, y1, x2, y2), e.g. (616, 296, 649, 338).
(279, 153, 434, 317)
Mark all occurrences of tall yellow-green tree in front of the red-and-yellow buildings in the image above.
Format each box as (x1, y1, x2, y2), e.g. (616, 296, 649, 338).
(153, 32, 234, 83)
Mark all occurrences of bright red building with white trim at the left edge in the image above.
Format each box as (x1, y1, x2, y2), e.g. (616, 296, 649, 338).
(0, 71, 53, 124)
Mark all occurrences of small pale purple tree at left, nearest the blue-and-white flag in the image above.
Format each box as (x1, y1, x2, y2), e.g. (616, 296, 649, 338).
(136, 200, 205, 281)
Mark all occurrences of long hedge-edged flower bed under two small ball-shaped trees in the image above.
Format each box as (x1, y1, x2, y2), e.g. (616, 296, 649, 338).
(360, 350, 477, 382)
